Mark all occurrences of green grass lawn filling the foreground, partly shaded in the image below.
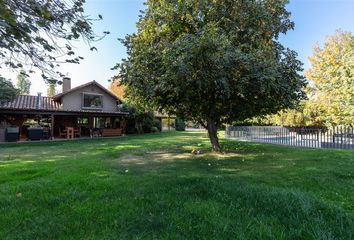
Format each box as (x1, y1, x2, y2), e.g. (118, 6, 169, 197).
(0, 132, 354, 240)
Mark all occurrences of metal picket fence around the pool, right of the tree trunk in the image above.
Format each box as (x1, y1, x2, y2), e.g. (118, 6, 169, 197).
(225, 126, 354, 149)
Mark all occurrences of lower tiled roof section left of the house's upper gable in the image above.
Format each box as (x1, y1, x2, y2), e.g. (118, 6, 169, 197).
(0, 95, 62, 111)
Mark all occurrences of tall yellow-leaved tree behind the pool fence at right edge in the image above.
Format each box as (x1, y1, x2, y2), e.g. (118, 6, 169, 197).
(305, 30, 354, 125)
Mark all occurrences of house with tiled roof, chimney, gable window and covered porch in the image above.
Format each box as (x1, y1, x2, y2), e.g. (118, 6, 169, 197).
(0, 78, 128, 141)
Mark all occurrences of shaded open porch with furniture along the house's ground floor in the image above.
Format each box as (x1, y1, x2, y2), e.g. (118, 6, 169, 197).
(0, 110, 126, 142)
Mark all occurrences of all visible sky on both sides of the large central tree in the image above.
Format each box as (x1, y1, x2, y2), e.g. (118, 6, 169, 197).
(1, 0, 354, 94)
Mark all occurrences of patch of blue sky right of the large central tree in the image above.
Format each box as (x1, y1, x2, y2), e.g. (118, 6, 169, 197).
(280, 0, 354, 69)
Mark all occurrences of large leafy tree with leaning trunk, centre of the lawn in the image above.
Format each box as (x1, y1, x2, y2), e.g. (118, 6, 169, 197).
(119, 0, 305, 152)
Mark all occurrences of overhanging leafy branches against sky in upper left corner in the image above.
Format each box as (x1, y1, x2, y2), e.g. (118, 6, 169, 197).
(0, 0, 108, 79)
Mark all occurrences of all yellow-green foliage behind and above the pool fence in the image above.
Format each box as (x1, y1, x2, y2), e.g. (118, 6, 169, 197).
(262, 30, 354, 127)
